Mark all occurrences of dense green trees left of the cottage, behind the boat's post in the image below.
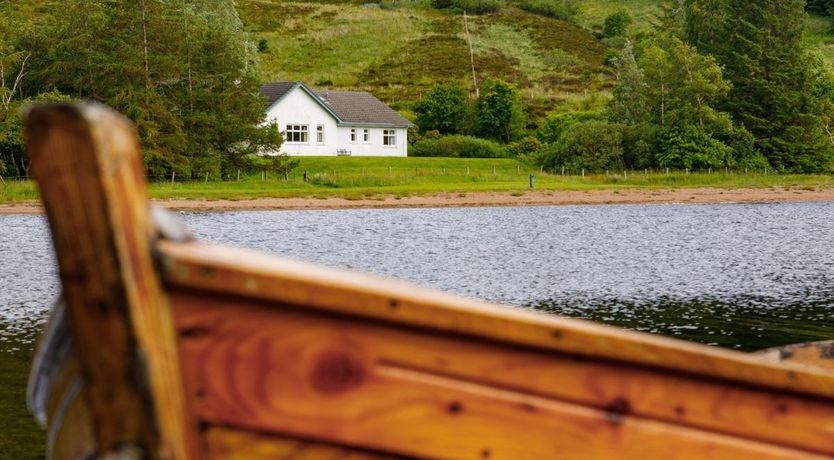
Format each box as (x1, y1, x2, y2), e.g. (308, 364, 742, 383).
(0, 0, 286, 177)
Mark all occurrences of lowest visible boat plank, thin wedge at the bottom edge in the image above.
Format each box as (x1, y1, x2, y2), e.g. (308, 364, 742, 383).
(204, 427, 404, 460)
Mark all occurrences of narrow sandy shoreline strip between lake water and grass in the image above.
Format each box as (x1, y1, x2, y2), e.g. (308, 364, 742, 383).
(0, 188, 834, 214)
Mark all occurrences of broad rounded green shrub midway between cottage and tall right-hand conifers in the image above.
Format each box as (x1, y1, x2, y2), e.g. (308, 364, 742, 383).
(542, 120, 623, 171)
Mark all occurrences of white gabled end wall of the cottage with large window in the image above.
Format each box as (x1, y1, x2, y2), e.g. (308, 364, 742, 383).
(267, 87, 339, 156)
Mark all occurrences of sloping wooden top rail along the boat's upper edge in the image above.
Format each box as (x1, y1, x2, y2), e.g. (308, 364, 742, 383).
(159, 242, 834, 398)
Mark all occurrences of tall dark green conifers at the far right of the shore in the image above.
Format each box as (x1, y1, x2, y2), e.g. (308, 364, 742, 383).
(685, 0, 834, 171)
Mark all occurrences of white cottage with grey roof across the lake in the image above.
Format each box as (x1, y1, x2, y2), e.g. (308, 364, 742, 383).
(260, 81, 413, 157)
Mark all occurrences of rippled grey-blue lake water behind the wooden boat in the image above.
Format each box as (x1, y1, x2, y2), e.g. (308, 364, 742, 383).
(0, 203, 834, 459)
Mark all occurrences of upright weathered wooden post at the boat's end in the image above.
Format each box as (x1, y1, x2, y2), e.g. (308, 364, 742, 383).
(25, 105, 195, 459)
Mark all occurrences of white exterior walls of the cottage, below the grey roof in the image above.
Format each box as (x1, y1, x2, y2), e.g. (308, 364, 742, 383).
(267, 87, 408, 157)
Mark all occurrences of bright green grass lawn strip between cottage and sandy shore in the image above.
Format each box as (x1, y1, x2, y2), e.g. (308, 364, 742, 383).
(0, 157, 834, 203)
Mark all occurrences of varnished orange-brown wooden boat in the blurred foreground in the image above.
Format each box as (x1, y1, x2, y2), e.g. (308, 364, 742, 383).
(27, 102, 834, 460)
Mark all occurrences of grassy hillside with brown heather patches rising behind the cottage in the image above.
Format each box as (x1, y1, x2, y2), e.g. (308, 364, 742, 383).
(238, 0, 834, 123)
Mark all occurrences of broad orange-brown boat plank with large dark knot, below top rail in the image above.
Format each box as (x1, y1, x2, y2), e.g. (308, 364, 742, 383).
(172, 292, 834, 459)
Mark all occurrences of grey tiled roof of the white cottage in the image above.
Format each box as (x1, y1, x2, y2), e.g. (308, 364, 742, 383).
(255, 81, 412, 126)
